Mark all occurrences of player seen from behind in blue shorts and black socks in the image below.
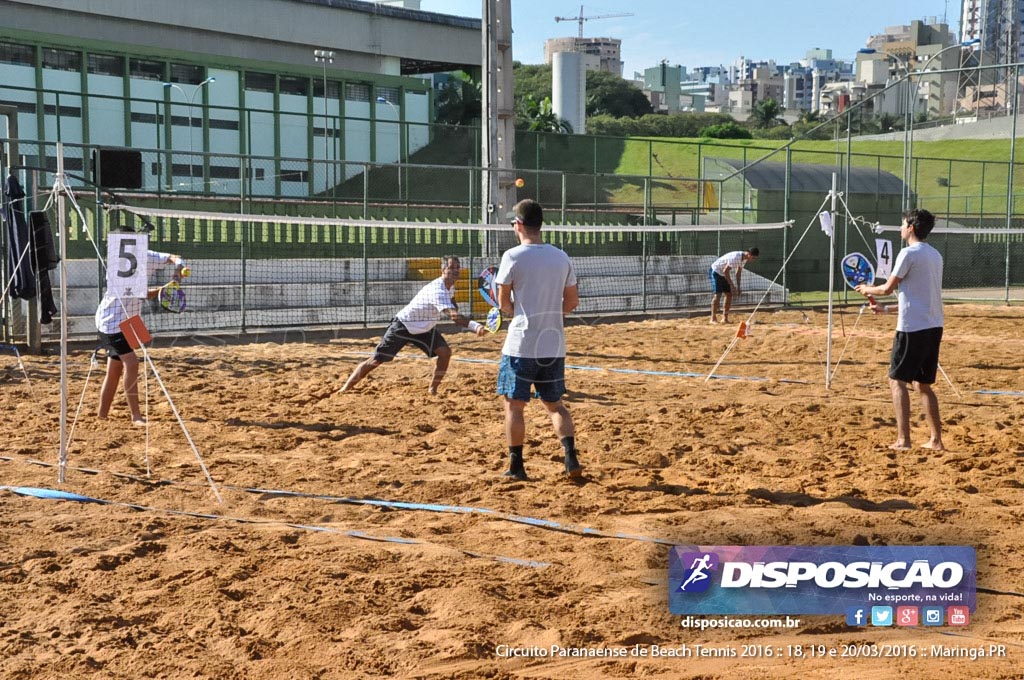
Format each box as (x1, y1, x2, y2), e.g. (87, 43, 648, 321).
(495, 199, 583, 481)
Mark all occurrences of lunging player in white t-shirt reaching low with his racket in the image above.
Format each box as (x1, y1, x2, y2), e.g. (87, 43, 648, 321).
(341, 255, 486, 394)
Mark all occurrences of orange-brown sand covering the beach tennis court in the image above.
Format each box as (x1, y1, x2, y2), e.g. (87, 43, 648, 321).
(0, 305, 1024, 680)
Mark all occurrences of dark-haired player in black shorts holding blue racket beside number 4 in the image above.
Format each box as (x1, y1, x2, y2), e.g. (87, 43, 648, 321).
(857, 210, 945, 451)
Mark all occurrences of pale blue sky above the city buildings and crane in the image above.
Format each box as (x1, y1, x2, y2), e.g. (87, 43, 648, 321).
(407, 0, 961, 76)
